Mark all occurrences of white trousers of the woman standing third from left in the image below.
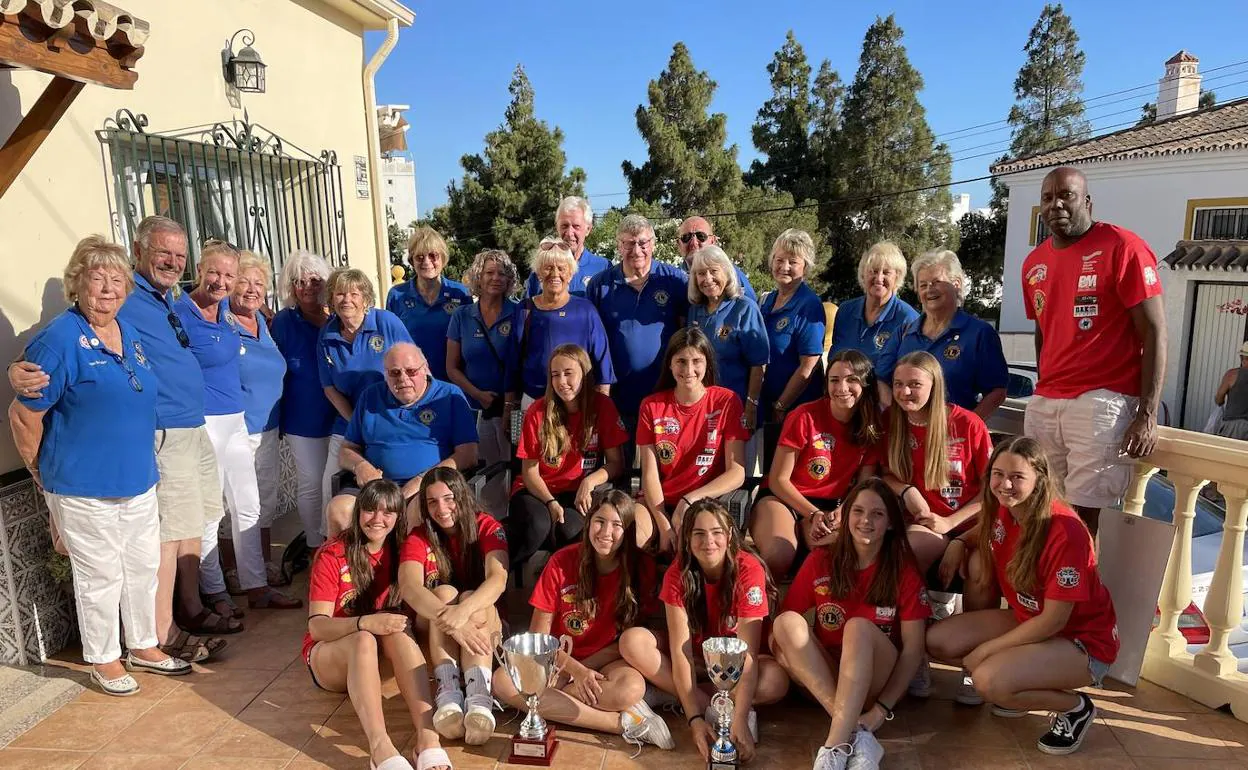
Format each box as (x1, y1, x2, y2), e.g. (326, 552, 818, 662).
(200, 412, 268, 594)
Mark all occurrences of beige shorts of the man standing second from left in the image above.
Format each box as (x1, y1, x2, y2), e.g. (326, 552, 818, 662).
(156, 426, 225, 543)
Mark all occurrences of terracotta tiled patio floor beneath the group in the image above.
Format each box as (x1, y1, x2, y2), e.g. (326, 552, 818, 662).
(0, 566, 1248, 770)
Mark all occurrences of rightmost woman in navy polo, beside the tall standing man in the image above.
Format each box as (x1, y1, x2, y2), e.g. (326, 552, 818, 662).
(879, 250, 1010, 422)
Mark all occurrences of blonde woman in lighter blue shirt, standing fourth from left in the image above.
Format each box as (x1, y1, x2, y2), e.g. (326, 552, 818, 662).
(229, 251, 290, 585)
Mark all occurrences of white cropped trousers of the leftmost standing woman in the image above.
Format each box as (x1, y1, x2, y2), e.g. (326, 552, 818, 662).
(44, 487, 160, 664)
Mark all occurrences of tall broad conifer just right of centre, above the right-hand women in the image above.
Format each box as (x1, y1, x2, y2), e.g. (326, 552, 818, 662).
(824, 15, 957, 300)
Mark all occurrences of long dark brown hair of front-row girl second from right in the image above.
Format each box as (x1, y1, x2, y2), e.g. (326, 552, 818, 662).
(817, 478, 919, 607)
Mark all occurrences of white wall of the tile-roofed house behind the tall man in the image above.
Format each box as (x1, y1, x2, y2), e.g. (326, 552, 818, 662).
(1001, 151, 1248, 419)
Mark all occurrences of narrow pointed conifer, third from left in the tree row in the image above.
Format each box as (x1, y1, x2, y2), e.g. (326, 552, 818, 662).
(745, 30, 814, 201)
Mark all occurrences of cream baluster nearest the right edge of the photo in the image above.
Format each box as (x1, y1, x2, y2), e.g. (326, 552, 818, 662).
(1194, 482, 1248, 676)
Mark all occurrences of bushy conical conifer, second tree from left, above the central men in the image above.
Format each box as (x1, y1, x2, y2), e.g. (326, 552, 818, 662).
(623, 42, 741, 216)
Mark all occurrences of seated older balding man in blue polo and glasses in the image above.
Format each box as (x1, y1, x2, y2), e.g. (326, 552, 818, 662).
(328, 342, 477, 538)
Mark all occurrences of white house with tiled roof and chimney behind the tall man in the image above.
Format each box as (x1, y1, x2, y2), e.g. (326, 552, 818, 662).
(992, 51, 1248, 431)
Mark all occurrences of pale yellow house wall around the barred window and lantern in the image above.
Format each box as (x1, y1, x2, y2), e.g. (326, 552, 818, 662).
(0, 0, 388, 473)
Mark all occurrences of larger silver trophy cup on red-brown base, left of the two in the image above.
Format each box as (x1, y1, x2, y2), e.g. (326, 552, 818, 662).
(499, 633, 572, 766)
